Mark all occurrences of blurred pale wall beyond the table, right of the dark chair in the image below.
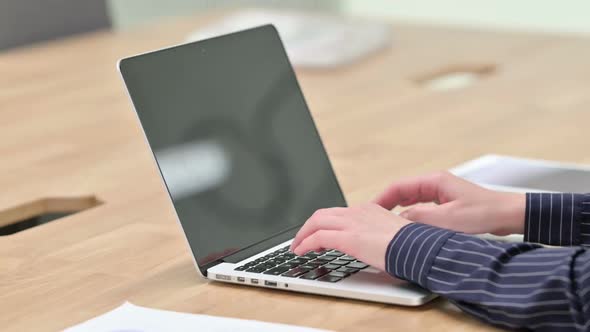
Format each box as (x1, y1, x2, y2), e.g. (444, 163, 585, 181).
(107, 0, 590, 33)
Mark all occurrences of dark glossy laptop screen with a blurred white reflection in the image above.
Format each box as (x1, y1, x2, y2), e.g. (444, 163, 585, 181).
(120, 25, 345, 266)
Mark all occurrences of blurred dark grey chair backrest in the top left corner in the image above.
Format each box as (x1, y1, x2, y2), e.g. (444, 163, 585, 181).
(0, 0, 111, 49)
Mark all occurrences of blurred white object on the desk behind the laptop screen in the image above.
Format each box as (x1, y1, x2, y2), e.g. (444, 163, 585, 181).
(188, 10, 392, 68)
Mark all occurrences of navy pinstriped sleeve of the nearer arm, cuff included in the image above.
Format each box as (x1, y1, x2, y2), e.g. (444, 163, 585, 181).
(385, 223, 590, 331)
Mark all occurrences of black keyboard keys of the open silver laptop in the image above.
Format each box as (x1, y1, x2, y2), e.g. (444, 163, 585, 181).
(234, 246, 368, 282)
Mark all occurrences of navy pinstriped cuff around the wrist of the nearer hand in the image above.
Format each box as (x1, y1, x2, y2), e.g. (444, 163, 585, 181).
(385, 223, 455, 287)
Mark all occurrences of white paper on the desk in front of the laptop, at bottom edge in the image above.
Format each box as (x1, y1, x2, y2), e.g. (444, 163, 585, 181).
(65, 302, 332, 332)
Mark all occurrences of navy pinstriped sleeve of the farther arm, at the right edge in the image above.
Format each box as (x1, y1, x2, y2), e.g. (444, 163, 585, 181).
(524, 193, 590, 246)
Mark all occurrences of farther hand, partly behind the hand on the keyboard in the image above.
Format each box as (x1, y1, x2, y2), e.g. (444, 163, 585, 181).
(375, 172, 526, 235)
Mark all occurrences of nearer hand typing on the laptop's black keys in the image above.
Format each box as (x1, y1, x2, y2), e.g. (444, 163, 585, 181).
(291, 203, 410, 270)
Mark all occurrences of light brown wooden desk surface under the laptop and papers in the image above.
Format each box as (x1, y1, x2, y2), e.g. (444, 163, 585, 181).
(0, 11, 590, 331)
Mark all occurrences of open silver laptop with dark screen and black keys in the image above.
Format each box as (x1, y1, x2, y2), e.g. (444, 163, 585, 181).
(119, 25, 434, 306)
